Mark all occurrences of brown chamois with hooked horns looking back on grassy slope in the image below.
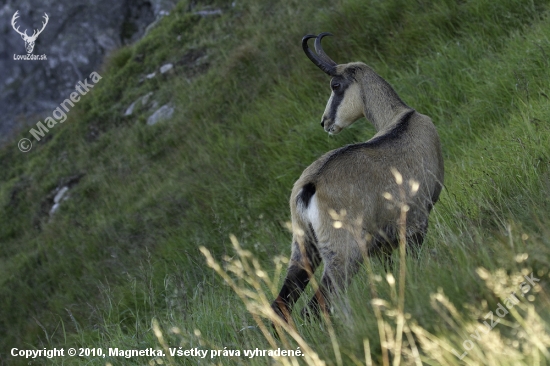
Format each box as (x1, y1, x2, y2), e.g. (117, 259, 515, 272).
(271, 33, 443, 321)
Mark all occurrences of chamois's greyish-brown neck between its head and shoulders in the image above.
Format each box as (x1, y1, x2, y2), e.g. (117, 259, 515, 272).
(362, 70, 411, 132)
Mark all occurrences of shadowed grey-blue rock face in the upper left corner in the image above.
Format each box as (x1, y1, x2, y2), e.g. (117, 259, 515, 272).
(0, 0, 176, 143)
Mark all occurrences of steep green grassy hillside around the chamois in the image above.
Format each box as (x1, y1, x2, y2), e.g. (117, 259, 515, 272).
(0, 0, 550, 365)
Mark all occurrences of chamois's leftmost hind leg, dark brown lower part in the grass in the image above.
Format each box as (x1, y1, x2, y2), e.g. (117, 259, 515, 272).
(271, 230, 321, 321)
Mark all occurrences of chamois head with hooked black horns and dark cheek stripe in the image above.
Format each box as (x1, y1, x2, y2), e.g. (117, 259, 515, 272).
(302, 33, 367, 135)
